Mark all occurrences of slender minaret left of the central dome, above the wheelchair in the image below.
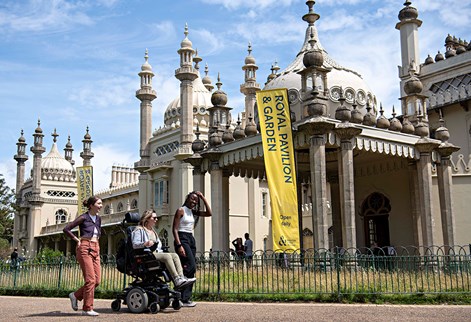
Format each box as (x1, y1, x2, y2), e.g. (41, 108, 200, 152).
(136, 49, 157, 171)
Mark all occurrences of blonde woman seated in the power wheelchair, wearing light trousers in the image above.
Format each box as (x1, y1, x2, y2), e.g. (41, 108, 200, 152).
(132, 209, 196, 288)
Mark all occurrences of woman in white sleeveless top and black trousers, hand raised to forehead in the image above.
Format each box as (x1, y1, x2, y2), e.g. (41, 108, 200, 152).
(173, 191, 211, 307)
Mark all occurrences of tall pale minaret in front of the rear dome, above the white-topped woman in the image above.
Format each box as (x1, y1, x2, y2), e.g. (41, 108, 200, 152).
(175, 24, 198, 160)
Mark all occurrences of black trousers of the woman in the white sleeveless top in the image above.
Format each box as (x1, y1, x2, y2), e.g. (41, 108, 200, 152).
(175, 231, 196, 302)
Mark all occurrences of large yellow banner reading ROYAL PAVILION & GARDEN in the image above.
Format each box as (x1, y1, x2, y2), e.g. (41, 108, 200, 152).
(257, 88, 300, 251)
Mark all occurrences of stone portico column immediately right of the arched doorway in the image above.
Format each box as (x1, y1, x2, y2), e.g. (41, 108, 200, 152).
(415, 138, 438, 247)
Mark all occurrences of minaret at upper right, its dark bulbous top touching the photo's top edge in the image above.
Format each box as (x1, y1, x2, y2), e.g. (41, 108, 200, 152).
(396, 1, 422, 78)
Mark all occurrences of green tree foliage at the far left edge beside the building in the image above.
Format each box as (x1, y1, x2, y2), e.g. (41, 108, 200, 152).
(0, 174, 16, 257)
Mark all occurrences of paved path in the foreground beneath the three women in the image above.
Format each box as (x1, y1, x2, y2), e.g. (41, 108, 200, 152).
(0, 296, 471, 322)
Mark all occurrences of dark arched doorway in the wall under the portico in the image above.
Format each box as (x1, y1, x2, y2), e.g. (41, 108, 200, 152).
(360, 192, 391, 247)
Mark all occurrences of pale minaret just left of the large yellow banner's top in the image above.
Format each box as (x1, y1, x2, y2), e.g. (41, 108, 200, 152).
(240, 43, 260, 117)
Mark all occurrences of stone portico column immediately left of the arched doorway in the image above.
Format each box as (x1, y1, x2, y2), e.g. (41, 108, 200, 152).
(334, 123, 362, 249)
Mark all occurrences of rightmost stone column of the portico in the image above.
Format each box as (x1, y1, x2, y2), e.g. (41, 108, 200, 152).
(437, 143, 460, 247)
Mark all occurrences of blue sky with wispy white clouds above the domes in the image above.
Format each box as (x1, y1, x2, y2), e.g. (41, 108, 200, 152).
(0, 0, 471, 191)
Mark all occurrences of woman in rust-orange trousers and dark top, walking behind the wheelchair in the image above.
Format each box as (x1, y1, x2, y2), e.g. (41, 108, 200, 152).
(64, 196, 103, 316)
